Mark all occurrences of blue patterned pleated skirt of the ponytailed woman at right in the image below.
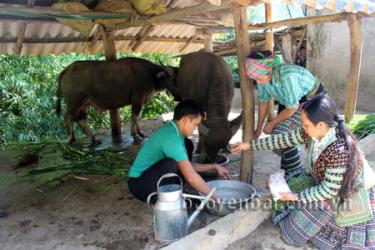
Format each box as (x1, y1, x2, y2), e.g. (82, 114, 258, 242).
(278, 177, 375, 249)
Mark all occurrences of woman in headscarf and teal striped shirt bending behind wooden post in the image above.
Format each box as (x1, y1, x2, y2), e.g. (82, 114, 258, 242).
(245, 51, 324, 177)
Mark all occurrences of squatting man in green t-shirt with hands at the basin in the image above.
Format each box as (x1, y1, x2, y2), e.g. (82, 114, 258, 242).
(128, 100, 230, 201)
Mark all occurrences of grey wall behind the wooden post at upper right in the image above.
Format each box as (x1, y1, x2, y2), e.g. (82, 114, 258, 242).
(307, 10, 375, 112)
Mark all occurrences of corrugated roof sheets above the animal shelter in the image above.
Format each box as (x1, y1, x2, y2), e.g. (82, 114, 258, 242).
(0, 0, 375, 55)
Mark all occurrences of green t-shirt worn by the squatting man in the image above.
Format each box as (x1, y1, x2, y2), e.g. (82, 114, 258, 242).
(129, 120, 189, 178)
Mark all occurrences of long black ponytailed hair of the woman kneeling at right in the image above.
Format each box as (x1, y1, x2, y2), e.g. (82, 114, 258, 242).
(302, 94, 362, 204)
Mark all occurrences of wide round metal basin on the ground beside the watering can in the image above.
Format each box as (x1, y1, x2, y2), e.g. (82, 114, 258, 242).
(201, 180, 257, 216)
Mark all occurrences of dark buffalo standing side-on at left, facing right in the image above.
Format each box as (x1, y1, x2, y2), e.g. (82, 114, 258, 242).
(56, 58, 172, 144)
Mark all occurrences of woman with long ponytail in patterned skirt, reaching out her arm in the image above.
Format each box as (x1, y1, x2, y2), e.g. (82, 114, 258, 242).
(232, 95, 375, 249)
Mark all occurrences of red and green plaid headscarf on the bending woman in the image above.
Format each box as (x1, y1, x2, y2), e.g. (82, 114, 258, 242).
(245, 54, 280, 79)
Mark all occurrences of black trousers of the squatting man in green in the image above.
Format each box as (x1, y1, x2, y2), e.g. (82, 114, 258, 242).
(128, 138, 194, 202)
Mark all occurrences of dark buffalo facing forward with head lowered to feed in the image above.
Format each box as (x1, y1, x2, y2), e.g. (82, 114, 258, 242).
(169, 51, 242, 161)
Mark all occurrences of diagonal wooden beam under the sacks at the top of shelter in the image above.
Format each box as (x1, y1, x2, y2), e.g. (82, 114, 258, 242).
(108, 0, 231, 30)
